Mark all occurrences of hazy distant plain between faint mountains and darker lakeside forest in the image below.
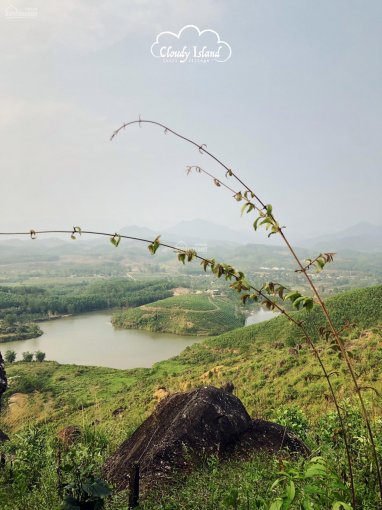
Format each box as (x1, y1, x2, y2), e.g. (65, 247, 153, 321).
(0, 238, 382, 296)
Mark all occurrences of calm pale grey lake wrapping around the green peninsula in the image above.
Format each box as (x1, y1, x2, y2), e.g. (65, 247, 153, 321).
(0, 309, 275, 368)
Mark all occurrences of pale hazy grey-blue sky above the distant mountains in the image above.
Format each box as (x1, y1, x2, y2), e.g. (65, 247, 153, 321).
(0, 0, 382, 242)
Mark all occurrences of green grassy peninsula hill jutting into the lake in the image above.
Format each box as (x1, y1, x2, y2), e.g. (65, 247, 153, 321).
(113, 294, 245, 336)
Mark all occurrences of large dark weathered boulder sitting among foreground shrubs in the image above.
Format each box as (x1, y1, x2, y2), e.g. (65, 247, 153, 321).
(103, 386, 307, 490)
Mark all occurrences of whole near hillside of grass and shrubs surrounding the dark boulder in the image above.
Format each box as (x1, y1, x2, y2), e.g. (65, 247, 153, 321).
(0, 286, 382, 510)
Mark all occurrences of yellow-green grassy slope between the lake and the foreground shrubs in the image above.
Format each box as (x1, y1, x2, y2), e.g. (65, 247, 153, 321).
(3, 286, 382, 434)
